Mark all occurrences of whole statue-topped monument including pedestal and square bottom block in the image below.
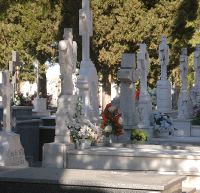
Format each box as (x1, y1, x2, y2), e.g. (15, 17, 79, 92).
(43, 28, 77, 168)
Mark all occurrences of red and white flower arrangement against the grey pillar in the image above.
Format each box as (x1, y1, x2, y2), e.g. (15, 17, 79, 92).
(101, 103, 123, 137)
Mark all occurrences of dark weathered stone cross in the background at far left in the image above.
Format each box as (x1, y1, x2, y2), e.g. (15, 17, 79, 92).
(9, 51, 22, 94)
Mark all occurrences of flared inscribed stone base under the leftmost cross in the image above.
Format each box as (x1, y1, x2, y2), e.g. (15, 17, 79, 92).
(0, 131, 28, 167)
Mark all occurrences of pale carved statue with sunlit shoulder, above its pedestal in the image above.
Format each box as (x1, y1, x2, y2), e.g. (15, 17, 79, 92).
(59, 28, 77, 95)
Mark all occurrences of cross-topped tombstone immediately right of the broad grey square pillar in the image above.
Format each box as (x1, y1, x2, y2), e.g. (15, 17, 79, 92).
(137, 44, 152, 129)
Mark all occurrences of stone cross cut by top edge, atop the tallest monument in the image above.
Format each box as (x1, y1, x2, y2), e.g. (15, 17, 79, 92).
(79, 0, 93, 61)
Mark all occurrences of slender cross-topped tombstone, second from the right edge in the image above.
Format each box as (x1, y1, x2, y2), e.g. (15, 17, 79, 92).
(178, 48, 192, 120)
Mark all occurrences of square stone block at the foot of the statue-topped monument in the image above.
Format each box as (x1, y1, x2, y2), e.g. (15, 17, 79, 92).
(42, 143, 75, 168)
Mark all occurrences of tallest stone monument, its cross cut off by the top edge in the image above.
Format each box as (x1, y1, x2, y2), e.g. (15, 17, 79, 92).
(77, 0, 99, 123)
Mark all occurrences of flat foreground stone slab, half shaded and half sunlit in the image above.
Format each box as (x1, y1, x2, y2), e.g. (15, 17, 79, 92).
(0, 168, 186, 193)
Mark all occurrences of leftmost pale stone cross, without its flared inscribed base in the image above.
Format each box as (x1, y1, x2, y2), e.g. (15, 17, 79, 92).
(0, 71, 13, 132)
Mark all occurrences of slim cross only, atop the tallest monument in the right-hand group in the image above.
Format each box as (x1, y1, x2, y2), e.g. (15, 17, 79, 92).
(159, 36, 169, 80)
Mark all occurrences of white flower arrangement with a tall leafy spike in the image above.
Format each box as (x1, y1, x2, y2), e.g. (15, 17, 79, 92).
(68, 98, 99, 146)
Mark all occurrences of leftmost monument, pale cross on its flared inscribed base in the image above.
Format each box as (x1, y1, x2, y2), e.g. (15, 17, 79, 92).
(0, 71, 28, 167)
